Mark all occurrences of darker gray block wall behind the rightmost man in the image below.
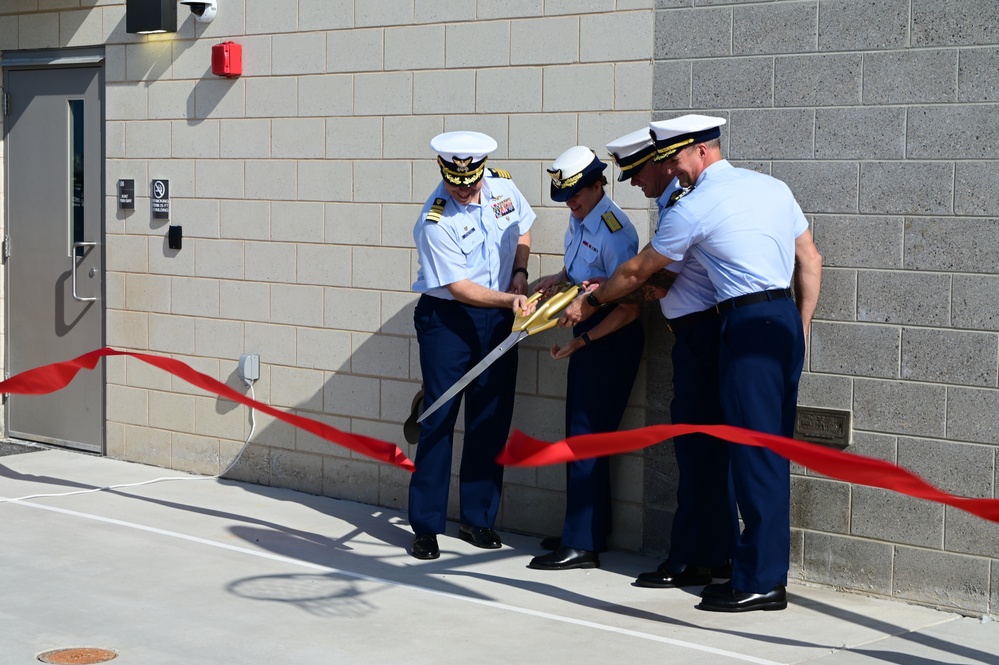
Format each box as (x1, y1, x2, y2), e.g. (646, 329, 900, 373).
(645, 0, 999, 614)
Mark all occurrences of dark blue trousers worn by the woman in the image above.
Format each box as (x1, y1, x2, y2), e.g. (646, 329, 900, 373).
(562, 309, 645, 552)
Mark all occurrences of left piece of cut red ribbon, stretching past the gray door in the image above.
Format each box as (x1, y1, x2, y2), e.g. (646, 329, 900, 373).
(0, 347, 416, 472)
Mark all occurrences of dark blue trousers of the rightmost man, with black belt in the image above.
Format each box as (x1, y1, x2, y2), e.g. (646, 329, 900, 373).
(719, 298, 805, 593)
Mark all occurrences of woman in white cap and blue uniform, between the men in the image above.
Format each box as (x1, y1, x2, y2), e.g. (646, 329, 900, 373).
(528, 146, 645, 570)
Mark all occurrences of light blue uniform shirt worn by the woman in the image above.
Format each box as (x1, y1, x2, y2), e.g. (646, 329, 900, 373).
(565, 194, 638, 284)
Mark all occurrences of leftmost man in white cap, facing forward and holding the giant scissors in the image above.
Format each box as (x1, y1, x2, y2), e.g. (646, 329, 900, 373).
(409, 131, 535, 559)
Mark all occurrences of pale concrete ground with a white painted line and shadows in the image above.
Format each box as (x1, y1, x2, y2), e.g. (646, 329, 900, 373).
(0, 450, 999, 665)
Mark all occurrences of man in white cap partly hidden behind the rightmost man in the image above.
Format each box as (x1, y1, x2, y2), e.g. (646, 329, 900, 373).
(607, 127, 739, 589)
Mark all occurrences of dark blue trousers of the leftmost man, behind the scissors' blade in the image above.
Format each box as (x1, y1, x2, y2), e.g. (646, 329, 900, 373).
(409, 295, 517, 533)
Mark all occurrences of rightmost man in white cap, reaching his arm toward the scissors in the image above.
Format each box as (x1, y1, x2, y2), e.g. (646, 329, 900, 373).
(559, 115, 822, 612)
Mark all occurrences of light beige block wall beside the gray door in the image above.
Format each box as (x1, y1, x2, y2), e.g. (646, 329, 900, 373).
(0, 0, 654, 549)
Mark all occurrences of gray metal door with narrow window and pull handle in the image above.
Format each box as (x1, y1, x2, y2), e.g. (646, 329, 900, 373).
(4, 66, 104, 453)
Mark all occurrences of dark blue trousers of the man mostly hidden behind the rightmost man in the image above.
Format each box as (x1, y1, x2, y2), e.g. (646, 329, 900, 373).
(668, 316, 739, 570)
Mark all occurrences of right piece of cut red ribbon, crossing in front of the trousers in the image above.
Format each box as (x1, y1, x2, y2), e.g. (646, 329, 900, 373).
(496, 425, 999, 522)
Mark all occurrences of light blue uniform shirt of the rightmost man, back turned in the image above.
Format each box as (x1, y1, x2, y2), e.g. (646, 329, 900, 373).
(652, 159, 808, 303)
